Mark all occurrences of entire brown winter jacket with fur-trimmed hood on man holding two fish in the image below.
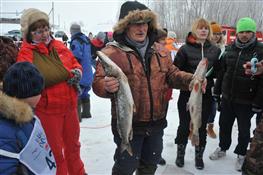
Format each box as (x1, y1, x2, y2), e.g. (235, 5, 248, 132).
(93, 4, 192, 134)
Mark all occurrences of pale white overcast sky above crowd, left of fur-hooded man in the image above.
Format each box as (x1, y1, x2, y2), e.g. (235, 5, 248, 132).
(0, 0, 146, 34)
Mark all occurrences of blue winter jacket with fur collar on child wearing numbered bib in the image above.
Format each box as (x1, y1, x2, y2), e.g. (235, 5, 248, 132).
(0, 92, 35, 175)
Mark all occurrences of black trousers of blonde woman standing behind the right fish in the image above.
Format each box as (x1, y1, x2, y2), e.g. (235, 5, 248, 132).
(175, 91, 212, 147)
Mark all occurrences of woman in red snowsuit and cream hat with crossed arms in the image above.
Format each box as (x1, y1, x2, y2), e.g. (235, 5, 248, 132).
(17, 8, 85, 175)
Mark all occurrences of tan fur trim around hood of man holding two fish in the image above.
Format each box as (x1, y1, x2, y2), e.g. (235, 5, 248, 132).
(113, 9, 158, 42)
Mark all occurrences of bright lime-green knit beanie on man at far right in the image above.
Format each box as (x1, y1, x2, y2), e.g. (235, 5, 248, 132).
(237, 17, 257, 33)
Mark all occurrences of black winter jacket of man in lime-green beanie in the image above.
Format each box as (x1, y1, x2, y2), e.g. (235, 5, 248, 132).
(214, 38, 263, 107)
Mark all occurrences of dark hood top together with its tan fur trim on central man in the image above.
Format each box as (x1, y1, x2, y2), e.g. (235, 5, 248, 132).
(113, 1, 157, 36)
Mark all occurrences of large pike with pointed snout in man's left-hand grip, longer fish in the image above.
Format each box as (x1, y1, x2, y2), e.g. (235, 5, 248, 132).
(97, 51, 135, 155)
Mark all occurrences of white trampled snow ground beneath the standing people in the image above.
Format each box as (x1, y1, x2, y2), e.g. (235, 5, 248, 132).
(80, 90, 255, 175)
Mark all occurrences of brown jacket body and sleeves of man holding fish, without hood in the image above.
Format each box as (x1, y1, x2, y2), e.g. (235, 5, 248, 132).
(93, 43, 192, 123)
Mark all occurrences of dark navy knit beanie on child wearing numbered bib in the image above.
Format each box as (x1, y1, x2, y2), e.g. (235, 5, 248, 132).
(3, 62, 44, 98)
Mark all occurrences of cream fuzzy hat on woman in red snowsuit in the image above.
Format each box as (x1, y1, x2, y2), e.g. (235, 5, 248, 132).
(20, 8, 49, 38)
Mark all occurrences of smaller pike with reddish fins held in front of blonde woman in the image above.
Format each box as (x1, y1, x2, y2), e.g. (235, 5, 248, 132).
(187, 58, 208, 146)
